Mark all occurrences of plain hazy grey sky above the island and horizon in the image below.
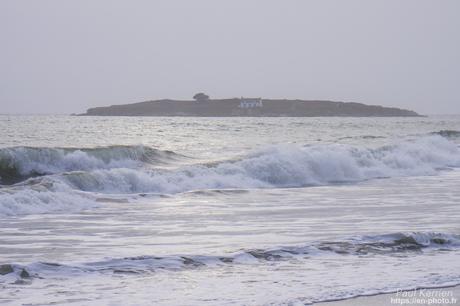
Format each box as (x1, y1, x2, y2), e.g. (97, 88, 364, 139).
(0, 0, 460, 114)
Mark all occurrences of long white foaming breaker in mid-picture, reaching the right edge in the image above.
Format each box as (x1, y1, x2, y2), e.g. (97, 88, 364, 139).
(60, 136, 460, 194)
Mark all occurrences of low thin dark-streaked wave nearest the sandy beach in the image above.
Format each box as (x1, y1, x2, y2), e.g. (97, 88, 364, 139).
(0, 232, 460, 278)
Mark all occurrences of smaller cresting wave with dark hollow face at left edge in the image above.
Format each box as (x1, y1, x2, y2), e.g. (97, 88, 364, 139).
(0, 145, 183, 184)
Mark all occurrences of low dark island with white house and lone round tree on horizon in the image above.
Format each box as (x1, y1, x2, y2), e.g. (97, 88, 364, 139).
(80, 93, 420, 117)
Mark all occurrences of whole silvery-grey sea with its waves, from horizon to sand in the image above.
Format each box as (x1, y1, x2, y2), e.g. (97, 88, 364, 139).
(0, 116, 460, 305)
